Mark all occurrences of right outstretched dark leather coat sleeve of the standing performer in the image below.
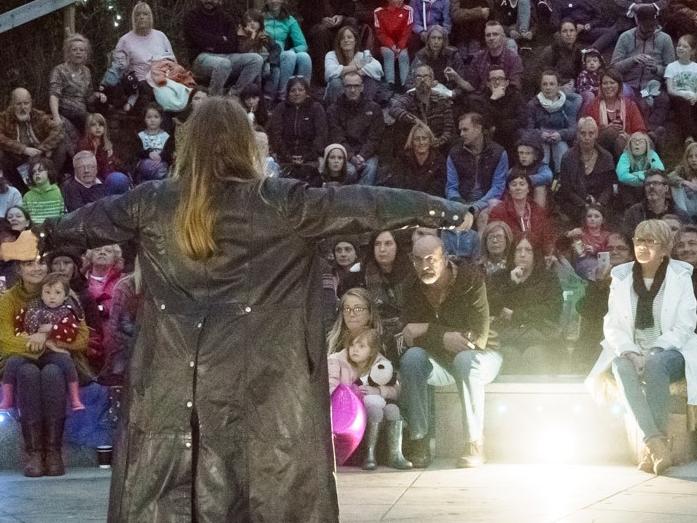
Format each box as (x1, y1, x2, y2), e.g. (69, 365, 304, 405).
(262, 180, 467, 240)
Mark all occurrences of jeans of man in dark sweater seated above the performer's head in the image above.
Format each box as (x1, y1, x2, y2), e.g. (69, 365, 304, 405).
(192, 53, 264, 95)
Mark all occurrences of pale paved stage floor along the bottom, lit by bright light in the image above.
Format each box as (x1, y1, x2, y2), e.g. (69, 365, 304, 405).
(0, 460, 697, 523)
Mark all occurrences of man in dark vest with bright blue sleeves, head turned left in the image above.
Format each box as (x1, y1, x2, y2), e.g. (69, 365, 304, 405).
(445, 113, 508, 218)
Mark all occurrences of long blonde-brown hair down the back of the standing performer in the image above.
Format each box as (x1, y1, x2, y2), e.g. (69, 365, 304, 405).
(173, 96, 264, 260)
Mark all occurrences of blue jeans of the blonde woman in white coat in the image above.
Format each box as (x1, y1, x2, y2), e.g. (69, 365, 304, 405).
(612, 349, 685, 442)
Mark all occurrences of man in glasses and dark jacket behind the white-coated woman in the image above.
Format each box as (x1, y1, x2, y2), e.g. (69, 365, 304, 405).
(623, 169, 690, 238)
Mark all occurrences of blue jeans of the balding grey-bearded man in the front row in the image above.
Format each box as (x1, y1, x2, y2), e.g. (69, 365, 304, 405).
(399, 347, 502, 442)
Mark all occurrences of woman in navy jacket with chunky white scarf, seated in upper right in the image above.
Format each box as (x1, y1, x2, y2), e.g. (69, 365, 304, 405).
(527, 70, 582, 173)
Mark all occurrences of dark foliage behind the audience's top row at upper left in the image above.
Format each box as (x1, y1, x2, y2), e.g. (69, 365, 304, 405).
(0, 0, 296, 109)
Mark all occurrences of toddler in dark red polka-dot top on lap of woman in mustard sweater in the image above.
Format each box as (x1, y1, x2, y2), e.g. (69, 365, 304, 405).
(0, 273, 85, 410)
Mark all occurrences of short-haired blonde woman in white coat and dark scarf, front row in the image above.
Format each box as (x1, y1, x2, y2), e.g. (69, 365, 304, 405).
(588, 220, 697, 474)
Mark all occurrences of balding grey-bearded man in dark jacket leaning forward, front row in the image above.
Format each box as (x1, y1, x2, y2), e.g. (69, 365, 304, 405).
(400, 236, 502, 468)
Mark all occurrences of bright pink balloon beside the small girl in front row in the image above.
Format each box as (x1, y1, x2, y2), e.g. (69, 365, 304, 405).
(332, 385, 368, 465)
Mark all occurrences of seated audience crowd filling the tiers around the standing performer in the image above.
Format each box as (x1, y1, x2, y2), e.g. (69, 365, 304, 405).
(0, 0, 697, 482)
